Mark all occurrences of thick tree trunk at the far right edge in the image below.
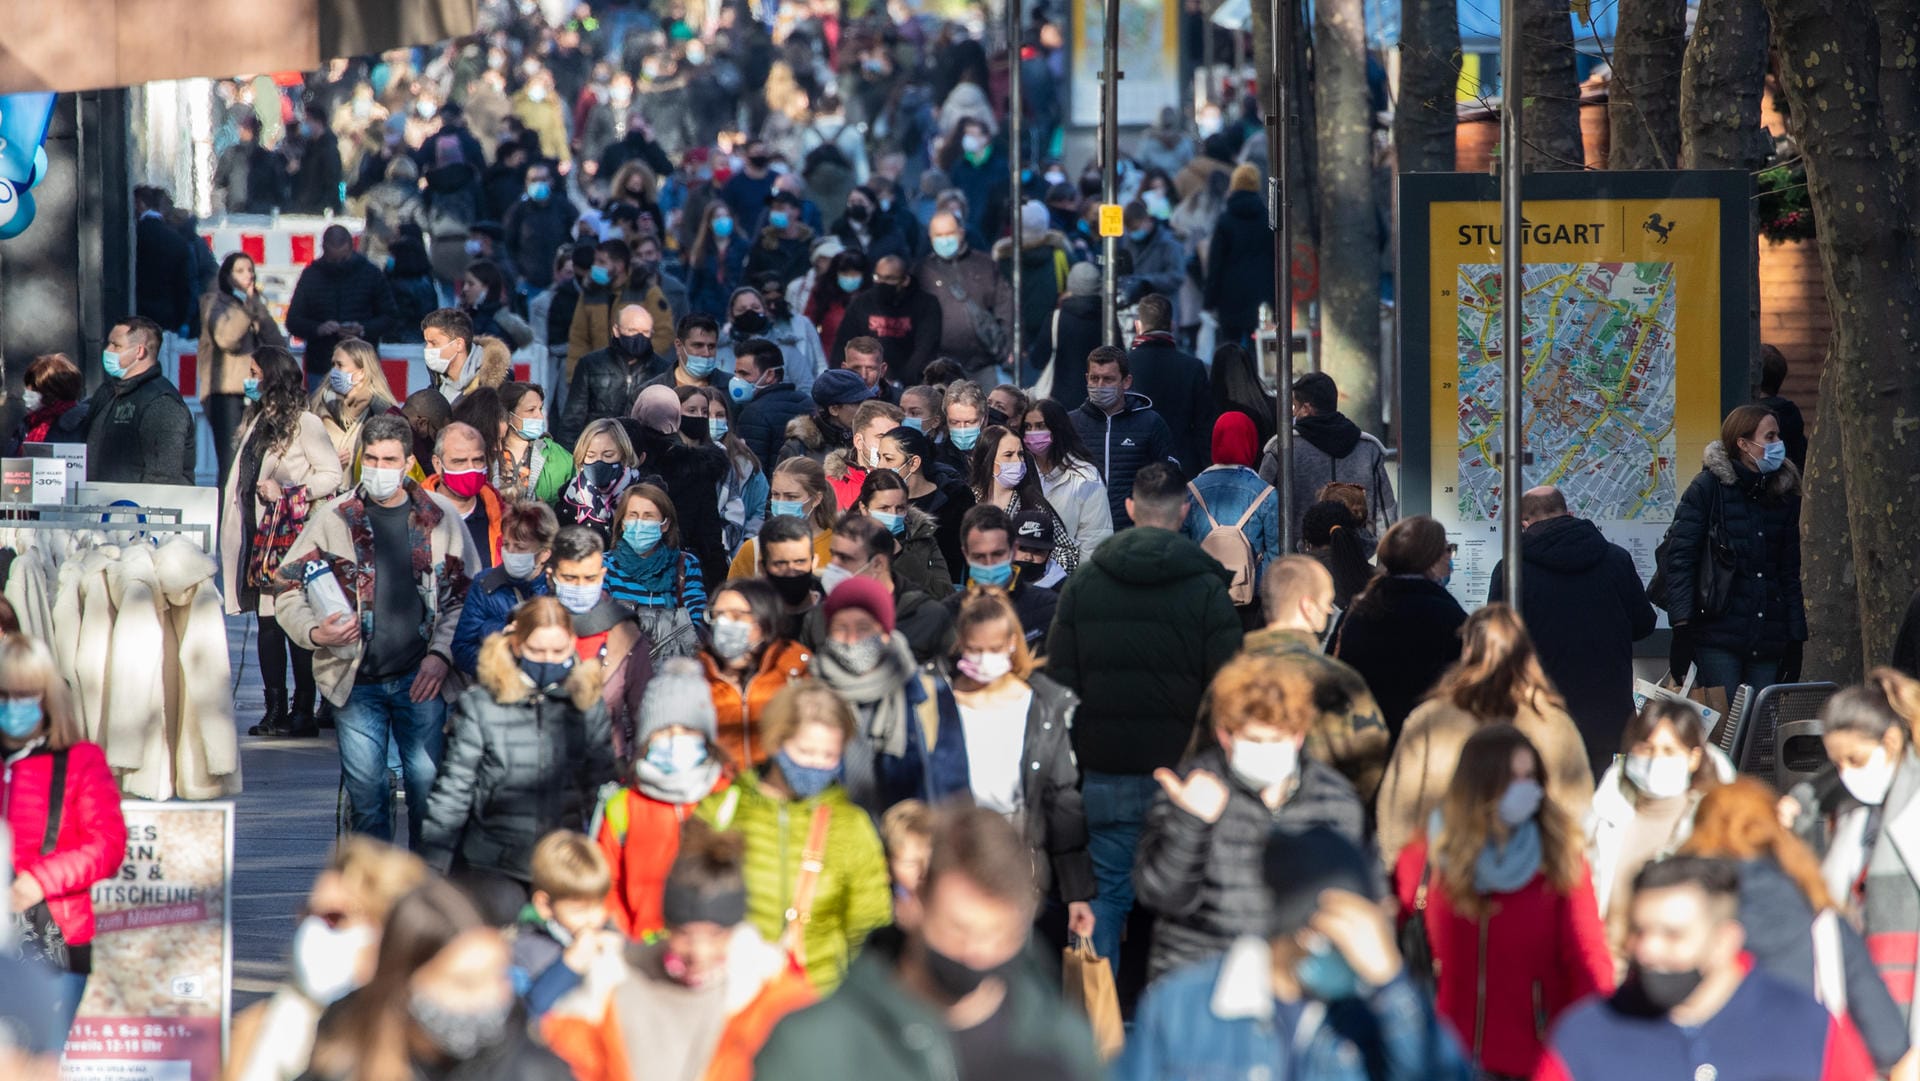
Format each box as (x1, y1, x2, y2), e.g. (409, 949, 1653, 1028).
(1766, 0, 1920, 664)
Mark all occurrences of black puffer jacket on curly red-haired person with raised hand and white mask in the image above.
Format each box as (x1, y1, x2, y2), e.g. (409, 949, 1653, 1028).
(1133, 745, 1367, 979)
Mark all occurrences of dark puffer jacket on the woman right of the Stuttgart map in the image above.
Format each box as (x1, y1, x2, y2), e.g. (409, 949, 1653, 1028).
(1667, 440, 1807, 659)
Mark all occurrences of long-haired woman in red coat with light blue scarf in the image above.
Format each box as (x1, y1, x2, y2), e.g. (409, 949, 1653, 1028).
(1394, 724, 1615, 1077)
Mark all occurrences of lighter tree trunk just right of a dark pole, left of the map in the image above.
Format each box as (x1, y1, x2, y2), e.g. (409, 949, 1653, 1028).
(1313, 0, 1380, 432)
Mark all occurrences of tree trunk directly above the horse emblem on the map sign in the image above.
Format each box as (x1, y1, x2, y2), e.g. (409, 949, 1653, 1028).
(1607, 0, 1686, 169)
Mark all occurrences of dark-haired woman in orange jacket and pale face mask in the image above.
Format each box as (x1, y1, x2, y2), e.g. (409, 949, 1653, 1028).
(699, 578, 812, 766)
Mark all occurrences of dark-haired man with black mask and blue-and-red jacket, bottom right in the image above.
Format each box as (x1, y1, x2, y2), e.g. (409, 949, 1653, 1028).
(1534, 856, 1876, 1081)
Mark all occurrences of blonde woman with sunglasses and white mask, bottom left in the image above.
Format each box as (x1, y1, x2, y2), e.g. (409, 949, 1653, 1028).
(221, 835, 426, 1081)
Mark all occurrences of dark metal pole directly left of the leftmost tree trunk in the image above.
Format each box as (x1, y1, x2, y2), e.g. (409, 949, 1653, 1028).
(1267, 0, 1300, 553)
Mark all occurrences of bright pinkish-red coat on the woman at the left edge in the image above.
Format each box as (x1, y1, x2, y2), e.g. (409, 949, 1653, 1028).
(0, 743, 127, 947)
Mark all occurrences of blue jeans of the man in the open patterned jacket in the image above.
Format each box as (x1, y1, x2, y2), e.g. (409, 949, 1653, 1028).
(334, 676, 447, 847)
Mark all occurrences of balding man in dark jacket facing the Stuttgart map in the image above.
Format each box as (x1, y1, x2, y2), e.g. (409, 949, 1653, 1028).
(1486, 486, 1653, 778)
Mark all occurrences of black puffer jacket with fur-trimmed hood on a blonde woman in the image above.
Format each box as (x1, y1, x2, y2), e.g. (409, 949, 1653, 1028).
(420, 634, 614, 881)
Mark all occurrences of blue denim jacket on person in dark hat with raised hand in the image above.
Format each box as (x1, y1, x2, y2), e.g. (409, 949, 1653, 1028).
(1112, 935, 1469, 1081)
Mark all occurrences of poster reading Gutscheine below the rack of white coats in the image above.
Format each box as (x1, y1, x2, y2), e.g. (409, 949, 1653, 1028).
(60, 801, 234, 1081)
